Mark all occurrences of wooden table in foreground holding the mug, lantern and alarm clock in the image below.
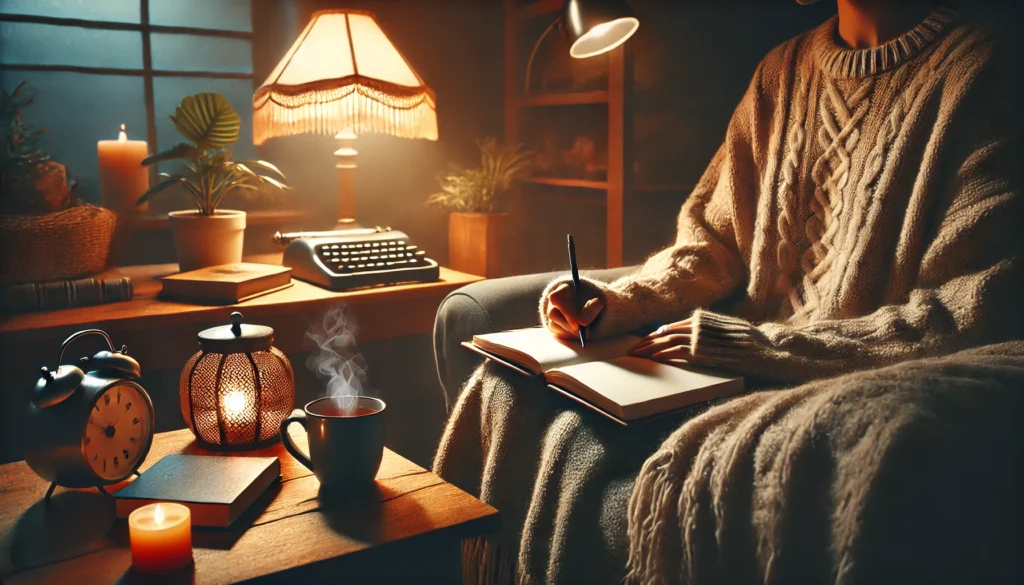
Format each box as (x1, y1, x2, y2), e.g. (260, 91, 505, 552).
(0, 429, 499, 585)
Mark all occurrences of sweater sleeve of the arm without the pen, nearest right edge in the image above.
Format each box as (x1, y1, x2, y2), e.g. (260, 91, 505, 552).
(690, 65, 1024, 382)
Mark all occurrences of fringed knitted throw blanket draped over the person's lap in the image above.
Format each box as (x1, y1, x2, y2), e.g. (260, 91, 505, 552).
(434, 341, 1024, 585)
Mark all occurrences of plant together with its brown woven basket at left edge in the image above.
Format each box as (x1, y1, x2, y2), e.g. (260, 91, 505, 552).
(0, 82, 117, 284)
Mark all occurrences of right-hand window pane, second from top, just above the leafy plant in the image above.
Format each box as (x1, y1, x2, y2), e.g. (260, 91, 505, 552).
(151, 33, 253, 74)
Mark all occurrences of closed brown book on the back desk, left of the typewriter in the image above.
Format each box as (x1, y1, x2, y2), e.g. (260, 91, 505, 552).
(160, 262, 292, 304)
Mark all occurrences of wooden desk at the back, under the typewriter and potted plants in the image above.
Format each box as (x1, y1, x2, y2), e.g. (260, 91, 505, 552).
(0, 254, 482, 461)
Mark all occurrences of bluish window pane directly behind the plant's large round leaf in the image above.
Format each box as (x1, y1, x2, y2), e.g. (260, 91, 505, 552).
(153, 77, 257, 162)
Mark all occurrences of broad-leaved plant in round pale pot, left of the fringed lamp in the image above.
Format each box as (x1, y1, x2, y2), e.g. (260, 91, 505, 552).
(138, 93, 288, 271)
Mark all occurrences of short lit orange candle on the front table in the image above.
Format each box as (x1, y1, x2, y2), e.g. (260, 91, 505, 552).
(128, 502, 193, 575)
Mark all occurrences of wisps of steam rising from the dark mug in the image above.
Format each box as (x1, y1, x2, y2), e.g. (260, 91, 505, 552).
(306, 306, 367, 414)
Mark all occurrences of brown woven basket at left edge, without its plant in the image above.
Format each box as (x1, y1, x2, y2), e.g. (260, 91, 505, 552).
(0, 204, 118, 284)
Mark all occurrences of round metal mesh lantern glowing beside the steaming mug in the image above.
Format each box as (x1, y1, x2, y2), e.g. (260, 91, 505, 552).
(180, 312, 295, 448)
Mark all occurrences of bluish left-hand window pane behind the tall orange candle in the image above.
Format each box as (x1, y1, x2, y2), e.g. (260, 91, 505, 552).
(0, 70, 145, 204)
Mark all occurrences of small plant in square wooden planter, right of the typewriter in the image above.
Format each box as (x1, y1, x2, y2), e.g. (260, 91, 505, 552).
(427, 137, 534, 278)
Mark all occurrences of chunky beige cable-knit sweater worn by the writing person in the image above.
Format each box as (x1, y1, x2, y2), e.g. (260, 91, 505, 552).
(541, 8, 1024, 382)
